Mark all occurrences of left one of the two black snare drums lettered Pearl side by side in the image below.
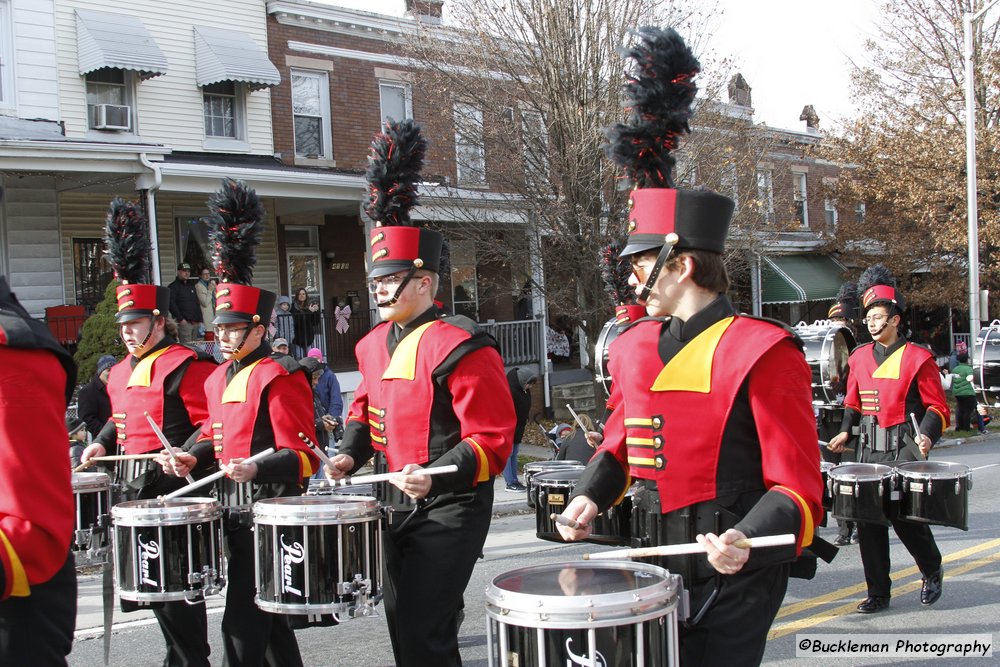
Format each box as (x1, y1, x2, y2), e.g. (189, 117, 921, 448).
(111, 498, 226, 602)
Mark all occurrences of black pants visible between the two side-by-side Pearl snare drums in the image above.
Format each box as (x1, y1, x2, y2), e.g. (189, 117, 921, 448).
(222, 527, 302, 667)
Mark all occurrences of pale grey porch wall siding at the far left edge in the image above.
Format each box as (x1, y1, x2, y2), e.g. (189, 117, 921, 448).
(3, 176, 62, 317)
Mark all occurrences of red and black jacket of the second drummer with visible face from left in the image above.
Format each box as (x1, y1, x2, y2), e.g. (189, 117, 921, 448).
(188, 344, 318, 495)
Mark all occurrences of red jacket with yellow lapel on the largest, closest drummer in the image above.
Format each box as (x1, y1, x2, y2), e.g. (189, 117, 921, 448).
(574, 296, 822, 559)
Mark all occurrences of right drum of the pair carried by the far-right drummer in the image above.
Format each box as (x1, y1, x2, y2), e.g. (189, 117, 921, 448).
(896, 461, 972, 530)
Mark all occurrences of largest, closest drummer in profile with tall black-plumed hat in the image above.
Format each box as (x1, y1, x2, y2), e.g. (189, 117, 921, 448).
(559, 28, 820, 666)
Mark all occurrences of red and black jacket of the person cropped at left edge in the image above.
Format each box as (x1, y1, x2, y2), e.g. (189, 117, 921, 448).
(0, 277, 76, 600)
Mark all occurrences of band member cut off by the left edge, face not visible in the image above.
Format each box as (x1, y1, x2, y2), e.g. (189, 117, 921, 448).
(0, 276, 76, 667)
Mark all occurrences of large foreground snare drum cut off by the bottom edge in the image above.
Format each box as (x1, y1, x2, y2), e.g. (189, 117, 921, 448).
(486, 561, 682, 667)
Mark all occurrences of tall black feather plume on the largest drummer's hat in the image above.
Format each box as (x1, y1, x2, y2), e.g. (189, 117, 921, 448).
(605, 26, 701, 188)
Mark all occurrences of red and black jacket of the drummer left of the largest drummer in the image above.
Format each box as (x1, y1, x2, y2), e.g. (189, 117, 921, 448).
(339, 307, 515, 495)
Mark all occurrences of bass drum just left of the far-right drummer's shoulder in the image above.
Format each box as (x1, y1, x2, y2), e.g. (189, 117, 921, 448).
(795, 321, 855, 407)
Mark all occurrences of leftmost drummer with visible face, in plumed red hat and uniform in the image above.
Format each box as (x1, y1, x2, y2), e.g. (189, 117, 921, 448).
(80, 198, 215, 666)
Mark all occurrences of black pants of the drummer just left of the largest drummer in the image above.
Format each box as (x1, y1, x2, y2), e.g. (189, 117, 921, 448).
(383, 479, 493, 667)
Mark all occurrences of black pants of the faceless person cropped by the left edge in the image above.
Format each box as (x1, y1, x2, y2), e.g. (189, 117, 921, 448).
(0, 554, 76, 667)
